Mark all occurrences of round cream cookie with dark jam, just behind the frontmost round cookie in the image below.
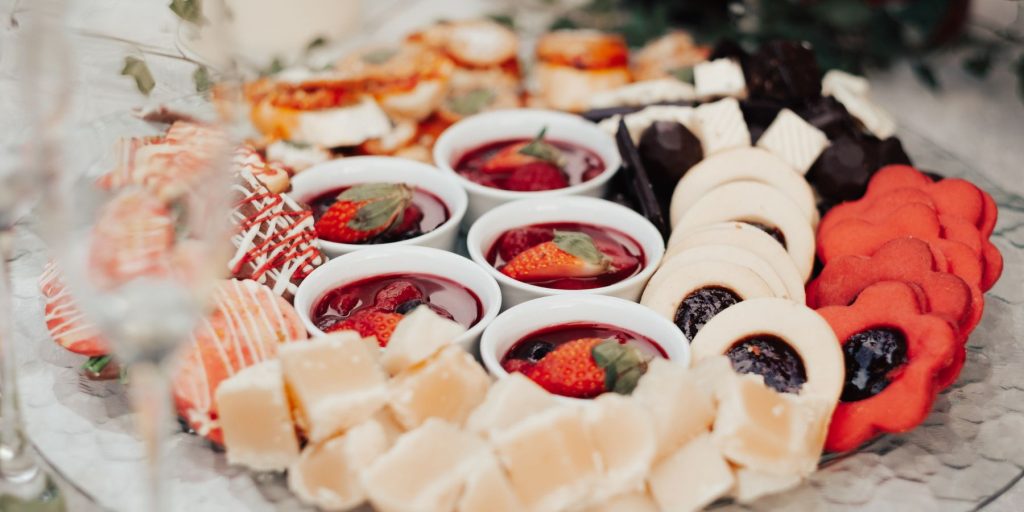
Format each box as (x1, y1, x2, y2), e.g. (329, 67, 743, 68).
(640, 260, 773, 340)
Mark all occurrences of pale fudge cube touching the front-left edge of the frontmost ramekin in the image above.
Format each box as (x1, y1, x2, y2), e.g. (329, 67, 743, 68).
(466, 372, 558, 437)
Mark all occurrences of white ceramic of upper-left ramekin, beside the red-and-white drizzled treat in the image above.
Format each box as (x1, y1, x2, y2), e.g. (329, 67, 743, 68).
(289, 157, 468, 258)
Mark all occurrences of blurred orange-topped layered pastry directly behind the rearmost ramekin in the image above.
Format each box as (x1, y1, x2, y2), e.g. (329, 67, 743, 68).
(537, 30, 630, 112)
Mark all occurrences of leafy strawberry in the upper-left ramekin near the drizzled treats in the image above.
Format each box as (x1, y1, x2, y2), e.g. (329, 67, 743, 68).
(315, 183, 413, 244)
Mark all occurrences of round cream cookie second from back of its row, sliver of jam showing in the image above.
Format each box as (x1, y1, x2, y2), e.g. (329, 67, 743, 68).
(674, 181, 814, 281)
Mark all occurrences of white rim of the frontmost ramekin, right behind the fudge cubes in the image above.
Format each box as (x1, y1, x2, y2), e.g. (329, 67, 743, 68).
(480, 295, 690, 387)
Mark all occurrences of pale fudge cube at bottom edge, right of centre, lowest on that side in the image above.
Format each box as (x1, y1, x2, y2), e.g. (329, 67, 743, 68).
(647, 434, 735, 512)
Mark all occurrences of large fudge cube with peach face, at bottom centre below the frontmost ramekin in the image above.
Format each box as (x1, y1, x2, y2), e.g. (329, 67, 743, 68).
(492, 406, 600, 512)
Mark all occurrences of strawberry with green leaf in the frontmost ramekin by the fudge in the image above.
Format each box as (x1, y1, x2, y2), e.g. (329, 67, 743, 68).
(522, 338, 647, 398)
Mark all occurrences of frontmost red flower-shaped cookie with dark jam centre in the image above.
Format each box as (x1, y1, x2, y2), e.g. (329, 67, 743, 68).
(818, 282, 964, 452)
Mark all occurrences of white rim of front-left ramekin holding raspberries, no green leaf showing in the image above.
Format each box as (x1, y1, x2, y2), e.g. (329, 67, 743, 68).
(295, 246, 502, 353)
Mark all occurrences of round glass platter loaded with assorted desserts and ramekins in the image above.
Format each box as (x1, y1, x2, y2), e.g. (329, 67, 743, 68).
(14, 16, 1024, 512)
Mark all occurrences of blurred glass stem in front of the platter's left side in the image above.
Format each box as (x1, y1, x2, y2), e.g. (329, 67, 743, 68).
(128, 361, 170, 512)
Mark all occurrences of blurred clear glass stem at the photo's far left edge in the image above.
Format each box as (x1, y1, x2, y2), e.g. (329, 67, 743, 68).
(0, 226, 39, 482)
